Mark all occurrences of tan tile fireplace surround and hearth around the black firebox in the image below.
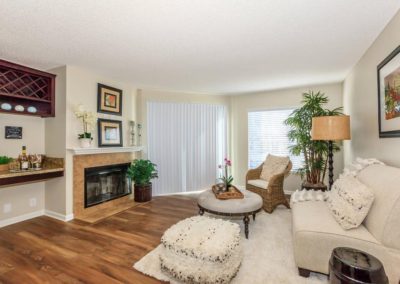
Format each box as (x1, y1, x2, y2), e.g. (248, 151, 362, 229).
(73, 153, 135, 223)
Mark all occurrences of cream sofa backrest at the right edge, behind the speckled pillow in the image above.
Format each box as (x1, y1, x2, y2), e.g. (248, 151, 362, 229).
(357, 165, 400, 249)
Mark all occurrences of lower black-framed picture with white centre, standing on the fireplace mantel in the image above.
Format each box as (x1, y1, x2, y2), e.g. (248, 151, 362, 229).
(97, 118, 122, 147)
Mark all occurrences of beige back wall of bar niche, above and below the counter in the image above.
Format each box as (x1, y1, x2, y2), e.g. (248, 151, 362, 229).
(0, 114, 45, 224)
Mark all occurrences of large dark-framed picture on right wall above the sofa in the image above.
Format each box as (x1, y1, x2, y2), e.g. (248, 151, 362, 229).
(378, 46, 400, 138)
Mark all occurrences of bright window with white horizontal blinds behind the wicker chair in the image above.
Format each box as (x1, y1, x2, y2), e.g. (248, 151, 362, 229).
(248, 109, 304, 170)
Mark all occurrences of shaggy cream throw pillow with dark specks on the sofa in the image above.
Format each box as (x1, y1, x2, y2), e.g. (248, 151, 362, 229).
(327, 176, 374, 230)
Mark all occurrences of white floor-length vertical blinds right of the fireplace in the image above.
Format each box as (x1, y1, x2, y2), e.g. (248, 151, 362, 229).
(147, 102, 227, 195)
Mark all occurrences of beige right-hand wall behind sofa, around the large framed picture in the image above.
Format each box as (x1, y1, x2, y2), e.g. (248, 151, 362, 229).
(343, 12, 400, 166)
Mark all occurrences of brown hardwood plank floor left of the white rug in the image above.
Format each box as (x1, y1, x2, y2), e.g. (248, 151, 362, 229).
(0, 196, 197, 284)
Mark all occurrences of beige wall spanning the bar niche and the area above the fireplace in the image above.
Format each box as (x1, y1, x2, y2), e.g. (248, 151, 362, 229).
(0, 66, 141, 224)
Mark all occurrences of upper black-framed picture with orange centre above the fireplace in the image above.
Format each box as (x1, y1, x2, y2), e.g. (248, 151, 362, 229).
(97, 84, 122, 115)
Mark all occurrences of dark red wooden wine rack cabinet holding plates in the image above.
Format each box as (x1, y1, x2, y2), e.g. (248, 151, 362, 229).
(0, 59, 56, 117)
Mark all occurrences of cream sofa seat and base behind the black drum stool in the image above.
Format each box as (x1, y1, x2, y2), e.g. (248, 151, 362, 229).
(292, 201, 388, 274)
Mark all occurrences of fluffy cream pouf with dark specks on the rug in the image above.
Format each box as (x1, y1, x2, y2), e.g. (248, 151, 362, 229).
(160, 216, 242, 284)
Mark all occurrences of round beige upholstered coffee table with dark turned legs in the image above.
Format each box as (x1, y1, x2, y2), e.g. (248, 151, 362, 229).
(197, 189, 263, 239)
